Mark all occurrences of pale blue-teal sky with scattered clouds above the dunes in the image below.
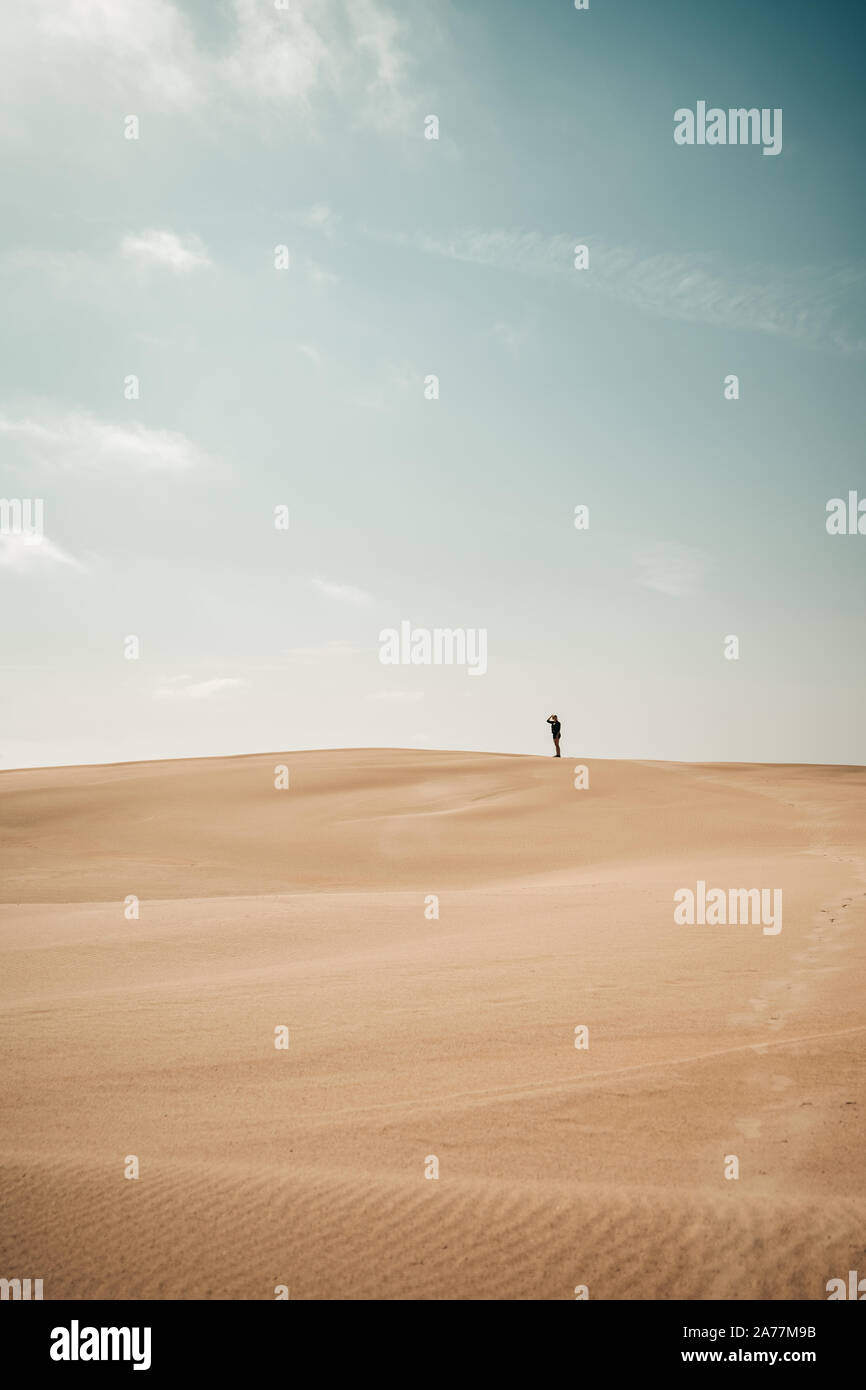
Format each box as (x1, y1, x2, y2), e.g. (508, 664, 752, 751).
(0, 0, 866, 767)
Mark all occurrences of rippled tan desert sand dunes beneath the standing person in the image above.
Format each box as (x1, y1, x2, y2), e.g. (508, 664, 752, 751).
(0, 749, 866, 1300)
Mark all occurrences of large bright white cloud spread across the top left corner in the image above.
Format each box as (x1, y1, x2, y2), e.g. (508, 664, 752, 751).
(4, 0, 424, 136)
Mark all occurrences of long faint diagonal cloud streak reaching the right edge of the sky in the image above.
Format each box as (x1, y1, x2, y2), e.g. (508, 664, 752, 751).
(391, 229, 866, 353)
